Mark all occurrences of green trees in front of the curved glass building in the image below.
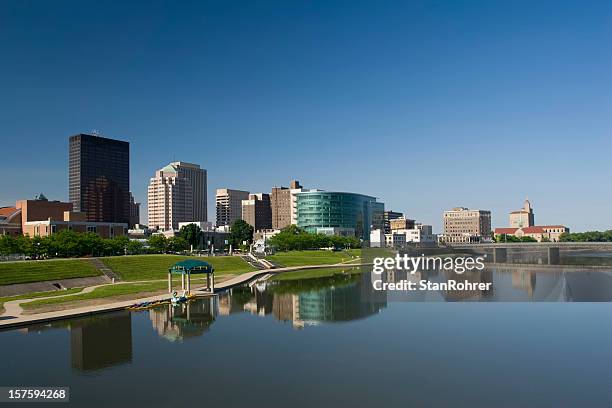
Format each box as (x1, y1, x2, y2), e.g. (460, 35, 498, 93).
(268, 225, 360, 251)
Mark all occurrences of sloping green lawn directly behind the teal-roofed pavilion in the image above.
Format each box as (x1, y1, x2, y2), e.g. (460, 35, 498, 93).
(101, 255, 255, 281)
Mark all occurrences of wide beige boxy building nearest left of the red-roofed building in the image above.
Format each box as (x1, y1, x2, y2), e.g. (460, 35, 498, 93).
(440, 207, 492, 243)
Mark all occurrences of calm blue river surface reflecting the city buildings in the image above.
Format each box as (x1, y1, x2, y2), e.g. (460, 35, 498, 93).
(0, 267, 612, 407)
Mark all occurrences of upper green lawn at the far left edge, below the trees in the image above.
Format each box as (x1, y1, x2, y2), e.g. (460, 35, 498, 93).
(0, 259, 100, 285)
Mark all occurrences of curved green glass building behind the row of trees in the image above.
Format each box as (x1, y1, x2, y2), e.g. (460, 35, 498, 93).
(295, 191, 385, 241)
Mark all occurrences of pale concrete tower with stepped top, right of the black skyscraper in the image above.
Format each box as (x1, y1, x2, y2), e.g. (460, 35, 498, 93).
(148, 163, 194, 231)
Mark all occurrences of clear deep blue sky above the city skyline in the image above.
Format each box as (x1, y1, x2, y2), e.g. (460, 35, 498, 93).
(0, 0, 612, 231)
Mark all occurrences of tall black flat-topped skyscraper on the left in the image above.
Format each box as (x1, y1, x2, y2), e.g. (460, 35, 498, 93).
(68, 134, 130, 223)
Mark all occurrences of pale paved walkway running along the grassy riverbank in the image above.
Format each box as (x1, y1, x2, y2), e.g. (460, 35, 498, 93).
(0, 263, 368, 330)
